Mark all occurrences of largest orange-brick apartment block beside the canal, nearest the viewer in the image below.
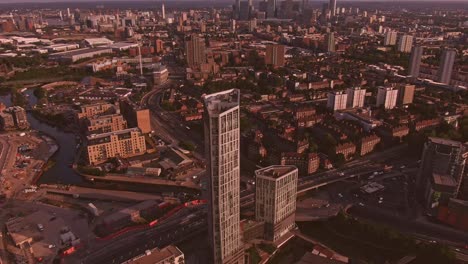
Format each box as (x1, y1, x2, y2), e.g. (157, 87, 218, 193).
(86, 128, 146, 165)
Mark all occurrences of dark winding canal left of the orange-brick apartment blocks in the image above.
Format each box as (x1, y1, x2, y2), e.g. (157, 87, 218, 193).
(0, 89, 83, 184)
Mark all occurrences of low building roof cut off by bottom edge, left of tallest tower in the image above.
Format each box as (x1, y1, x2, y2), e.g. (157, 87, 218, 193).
(122, 245, 186, 264)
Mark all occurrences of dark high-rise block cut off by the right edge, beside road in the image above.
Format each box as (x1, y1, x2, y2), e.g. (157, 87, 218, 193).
(416, 137, 468, 205)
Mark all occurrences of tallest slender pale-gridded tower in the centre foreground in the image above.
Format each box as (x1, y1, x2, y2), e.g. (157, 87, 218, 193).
(203, 89, 244, 264)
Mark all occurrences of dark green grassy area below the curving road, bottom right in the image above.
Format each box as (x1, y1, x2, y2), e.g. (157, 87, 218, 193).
(298, 213, 455, 264)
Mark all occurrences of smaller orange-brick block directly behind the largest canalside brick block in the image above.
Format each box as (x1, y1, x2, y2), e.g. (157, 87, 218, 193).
(86, 114, 127, 134)
